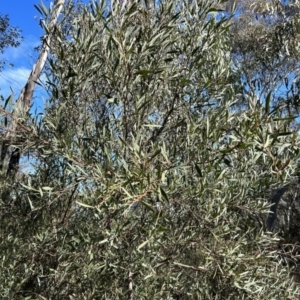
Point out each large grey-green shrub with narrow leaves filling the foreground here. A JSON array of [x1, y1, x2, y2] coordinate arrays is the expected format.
[[0, 0, 299, 299]]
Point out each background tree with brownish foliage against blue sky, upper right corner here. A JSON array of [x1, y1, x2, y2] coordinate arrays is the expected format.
[[223, 0, 300, 125]]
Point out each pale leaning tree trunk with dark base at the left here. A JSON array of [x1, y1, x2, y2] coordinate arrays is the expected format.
[[0, 0, 65, 178]]
